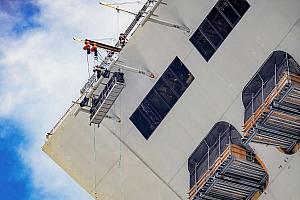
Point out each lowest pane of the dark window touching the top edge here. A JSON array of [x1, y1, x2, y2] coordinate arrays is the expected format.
[[190, 30, 215, 61]]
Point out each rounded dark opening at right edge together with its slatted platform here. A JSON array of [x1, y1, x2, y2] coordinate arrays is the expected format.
[[243, 51, 300, 153]]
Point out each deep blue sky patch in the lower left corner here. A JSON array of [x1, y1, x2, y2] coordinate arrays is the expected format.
[[0, 119, 32, 200]]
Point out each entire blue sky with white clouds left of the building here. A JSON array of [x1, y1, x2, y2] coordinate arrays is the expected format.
[[0, 0, 137, 200]]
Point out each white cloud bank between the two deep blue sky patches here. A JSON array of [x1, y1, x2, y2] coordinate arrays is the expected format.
[[0, 0, 144, 200]]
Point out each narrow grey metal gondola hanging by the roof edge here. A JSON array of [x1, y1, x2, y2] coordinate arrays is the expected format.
[[90, 72, 125, 124]]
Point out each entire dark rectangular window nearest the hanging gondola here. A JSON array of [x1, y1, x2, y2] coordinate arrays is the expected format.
[[130, 57, 194, 139]]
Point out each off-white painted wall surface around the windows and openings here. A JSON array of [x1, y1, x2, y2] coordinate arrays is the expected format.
[[43, 0, 300, 200]]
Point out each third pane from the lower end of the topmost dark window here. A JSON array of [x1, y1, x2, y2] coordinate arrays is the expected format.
[[207, 8, 232, 38]]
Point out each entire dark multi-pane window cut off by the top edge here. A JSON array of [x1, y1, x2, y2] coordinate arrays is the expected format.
[[190, 0, 250, 61]]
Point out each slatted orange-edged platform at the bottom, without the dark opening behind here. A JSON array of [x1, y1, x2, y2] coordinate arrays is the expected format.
[[190, 145, 268, 200]]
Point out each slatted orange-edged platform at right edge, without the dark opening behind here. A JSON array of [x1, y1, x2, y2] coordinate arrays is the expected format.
[[244, 74, 300, 152]]
